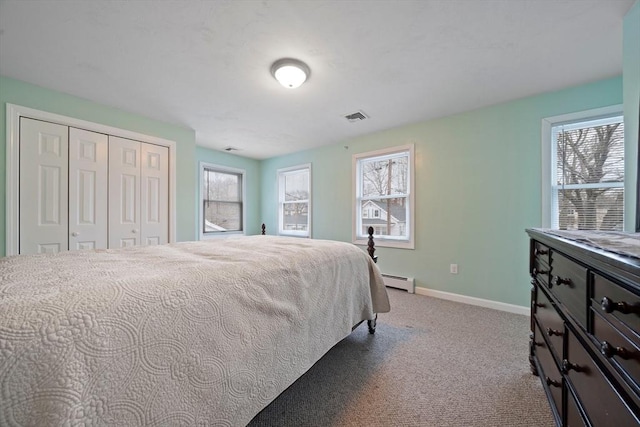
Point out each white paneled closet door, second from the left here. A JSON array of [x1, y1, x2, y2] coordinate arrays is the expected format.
[[69, 128, 109, 251]]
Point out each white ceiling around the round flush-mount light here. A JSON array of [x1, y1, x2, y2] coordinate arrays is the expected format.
[[0, 0, 634, 159]]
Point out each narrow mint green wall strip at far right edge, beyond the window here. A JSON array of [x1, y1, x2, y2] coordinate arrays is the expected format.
[[622, 0, 640, 231]]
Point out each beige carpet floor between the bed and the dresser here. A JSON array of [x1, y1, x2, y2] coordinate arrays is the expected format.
[[249, 289, 554, 427]]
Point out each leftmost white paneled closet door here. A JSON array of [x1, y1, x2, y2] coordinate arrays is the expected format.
[[19, 117, 69, 254]]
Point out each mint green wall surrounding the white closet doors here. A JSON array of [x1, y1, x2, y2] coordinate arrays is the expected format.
[[0, 76, 196, 256]]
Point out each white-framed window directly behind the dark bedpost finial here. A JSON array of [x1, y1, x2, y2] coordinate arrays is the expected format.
[[353, 145, 415, 249]]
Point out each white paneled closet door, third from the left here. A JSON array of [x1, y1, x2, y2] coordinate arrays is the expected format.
[[109, 136, 141, 248]]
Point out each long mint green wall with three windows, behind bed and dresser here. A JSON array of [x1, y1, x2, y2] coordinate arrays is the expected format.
[[262, 77, 622, 306]]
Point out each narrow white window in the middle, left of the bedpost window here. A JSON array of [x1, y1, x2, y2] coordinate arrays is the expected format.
[[278, 164, 311, 237]]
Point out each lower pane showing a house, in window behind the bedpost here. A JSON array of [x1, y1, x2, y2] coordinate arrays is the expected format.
[[360, 197, 407, 239]]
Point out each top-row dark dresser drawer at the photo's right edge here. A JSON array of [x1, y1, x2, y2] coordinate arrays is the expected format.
[[593, 274, 640, 344]]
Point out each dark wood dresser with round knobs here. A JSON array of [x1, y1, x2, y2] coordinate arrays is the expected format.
[[527, 229, 640, 426]]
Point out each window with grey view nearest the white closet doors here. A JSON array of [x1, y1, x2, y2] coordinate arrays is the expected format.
[[200, 163, 244, 238]]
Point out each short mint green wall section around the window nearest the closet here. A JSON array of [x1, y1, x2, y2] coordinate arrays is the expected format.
[[195, 147, 262, 234]]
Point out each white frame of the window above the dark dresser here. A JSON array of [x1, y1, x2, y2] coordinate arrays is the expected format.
[[542, 104, 627, 229]]
